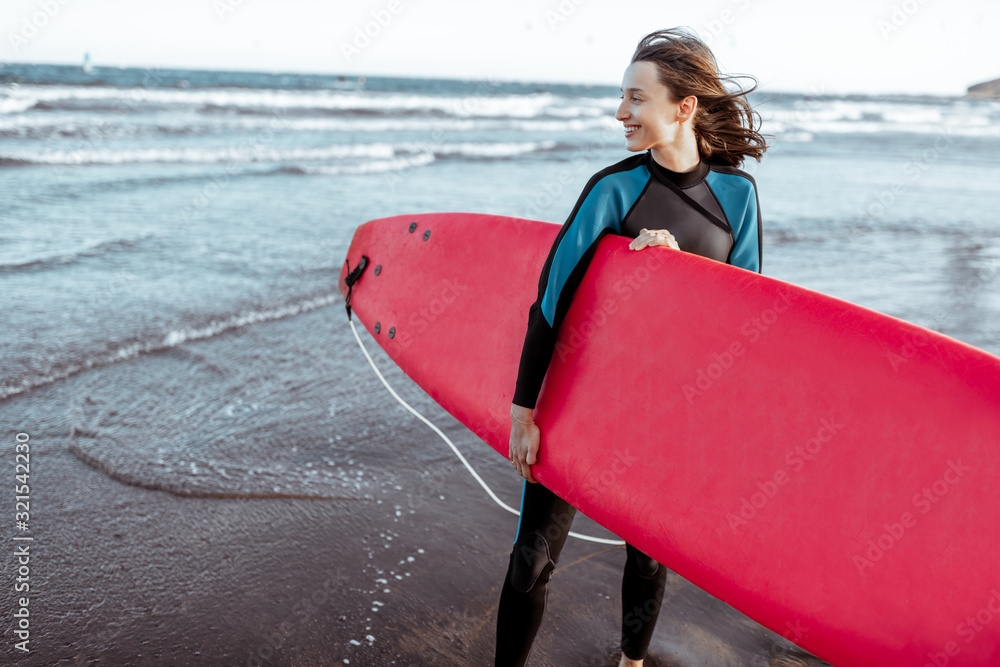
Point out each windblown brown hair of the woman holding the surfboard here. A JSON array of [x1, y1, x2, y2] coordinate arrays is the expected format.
[[632, 28, 767, 167]]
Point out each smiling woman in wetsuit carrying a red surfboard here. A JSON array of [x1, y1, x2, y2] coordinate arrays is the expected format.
[[495, 28, 767, 667]]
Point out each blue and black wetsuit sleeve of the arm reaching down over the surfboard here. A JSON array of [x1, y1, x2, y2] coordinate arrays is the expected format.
[[513, 174, 625, 408]]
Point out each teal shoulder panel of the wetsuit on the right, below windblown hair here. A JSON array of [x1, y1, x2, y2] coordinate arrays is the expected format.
[[705, 167, 762, 273]]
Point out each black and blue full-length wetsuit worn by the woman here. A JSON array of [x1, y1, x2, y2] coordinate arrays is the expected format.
[[495, 151, 763, 667]]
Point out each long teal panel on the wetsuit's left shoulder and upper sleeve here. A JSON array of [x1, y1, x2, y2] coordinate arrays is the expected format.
[[542, 165, 650, 327]]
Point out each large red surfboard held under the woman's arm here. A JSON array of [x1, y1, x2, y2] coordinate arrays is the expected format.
[[340, 213, 1000, 667]]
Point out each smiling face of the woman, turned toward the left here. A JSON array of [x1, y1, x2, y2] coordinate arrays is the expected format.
[[615, 60, 697, 152]]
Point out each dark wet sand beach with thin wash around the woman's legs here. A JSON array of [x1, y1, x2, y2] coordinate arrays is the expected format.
[[0, 304, 823, 666]]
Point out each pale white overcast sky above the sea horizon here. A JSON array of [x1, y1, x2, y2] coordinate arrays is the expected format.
[[0, 0, 1000, 95]]
